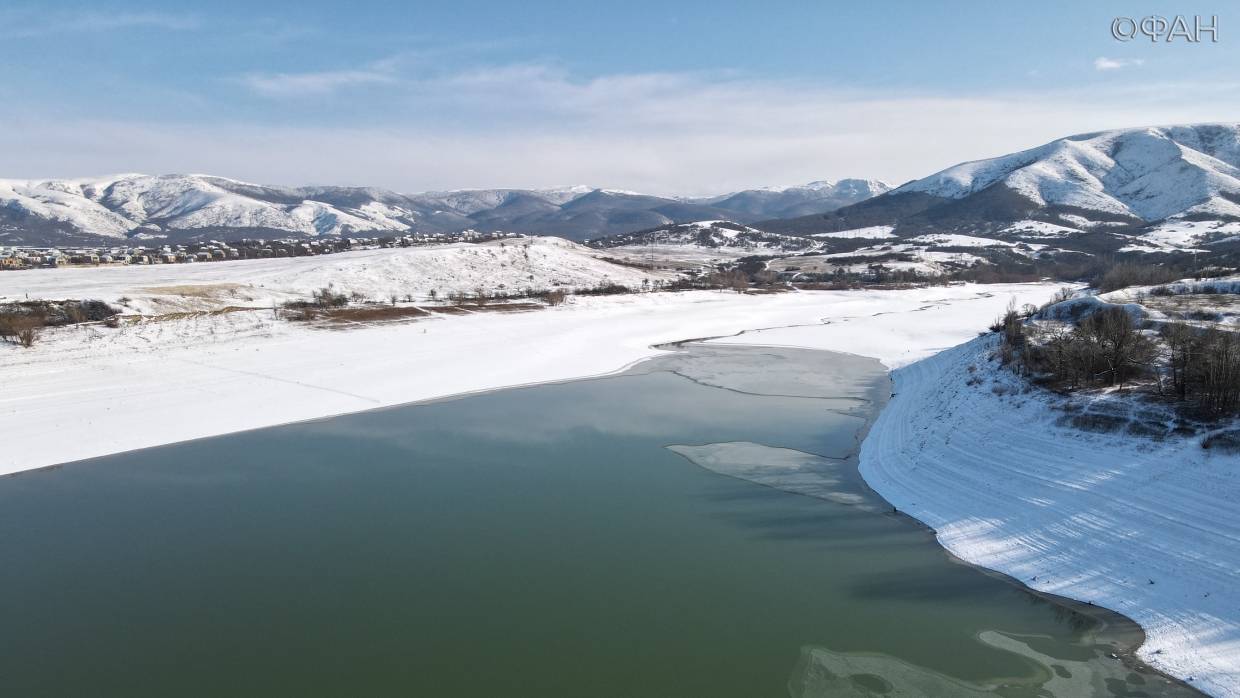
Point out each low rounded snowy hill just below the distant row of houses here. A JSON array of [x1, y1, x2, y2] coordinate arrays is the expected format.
[[0, 238, 671, 315]]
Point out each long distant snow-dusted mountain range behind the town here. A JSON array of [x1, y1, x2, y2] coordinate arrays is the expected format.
[[0, 175, 885, 244]]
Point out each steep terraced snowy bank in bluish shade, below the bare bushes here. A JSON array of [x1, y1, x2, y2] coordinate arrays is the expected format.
[[861, 337, 1240, 696]]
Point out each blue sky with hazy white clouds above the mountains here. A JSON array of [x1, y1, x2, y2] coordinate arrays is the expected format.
[[0, 0, 1240, 195]]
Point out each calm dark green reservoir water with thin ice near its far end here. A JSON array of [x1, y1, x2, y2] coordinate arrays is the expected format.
[[0, 348, 1192, 698]]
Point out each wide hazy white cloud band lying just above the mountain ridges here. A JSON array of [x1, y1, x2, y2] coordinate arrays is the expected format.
[[0, 64, 1240, 195]]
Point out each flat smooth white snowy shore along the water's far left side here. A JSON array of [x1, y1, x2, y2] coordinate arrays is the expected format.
[[0, 278, 1053, 474]]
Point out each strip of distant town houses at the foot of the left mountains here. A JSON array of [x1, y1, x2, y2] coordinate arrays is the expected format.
[[0, 231, 525, 270]]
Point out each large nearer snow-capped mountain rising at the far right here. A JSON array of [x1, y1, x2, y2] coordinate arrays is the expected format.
[[763, 123, 1240, 246]]
